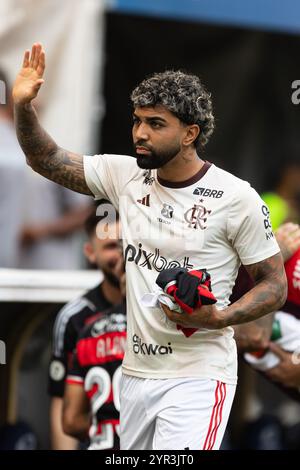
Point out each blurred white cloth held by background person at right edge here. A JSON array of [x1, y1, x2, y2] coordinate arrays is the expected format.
[[244, 311, 300, 371]]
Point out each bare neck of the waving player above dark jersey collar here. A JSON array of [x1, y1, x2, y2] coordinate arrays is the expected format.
[[157, 149, 204, 182]]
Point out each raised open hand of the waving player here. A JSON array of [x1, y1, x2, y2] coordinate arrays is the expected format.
[[12, 43, 45, 105]]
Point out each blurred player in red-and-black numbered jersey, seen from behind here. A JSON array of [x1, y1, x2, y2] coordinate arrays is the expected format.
[[63, 264, 126, 450]]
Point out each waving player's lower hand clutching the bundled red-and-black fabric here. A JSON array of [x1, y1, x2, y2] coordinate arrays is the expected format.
[[160, 303, 226, 330]]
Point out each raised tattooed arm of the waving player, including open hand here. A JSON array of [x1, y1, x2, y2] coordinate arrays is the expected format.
[[13, 44, 92, 195]]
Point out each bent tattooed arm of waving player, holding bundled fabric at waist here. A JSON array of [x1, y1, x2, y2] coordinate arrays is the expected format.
[[161, 253, 287, 329]]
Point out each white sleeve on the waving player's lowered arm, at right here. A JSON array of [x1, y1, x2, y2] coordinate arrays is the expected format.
[[227, 183, 280, 265]]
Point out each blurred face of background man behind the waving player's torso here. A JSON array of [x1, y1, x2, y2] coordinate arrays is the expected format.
[[84, 222, 123, 286]]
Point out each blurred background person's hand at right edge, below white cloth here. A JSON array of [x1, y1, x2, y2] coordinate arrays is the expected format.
[[265, 343, 300, 388]]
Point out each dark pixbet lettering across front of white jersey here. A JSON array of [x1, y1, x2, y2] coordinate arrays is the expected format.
[[125, 243, 194, 272]]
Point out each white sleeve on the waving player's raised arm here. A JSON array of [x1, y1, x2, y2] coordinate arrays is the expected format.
[[83, 155, 138, 208]]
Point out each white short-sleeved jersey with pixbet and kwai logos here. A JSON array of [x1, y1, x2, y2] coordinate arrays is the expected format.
[[84, 155, 279, 384]]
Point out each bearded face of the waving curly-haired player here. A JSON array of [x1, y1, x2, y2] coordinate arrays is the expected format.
[[132, 106, 186, 169]]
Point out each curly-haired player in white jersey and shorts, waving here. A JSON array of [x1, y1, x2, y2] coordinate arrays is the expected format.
[[13, 44, 286, 450]]
